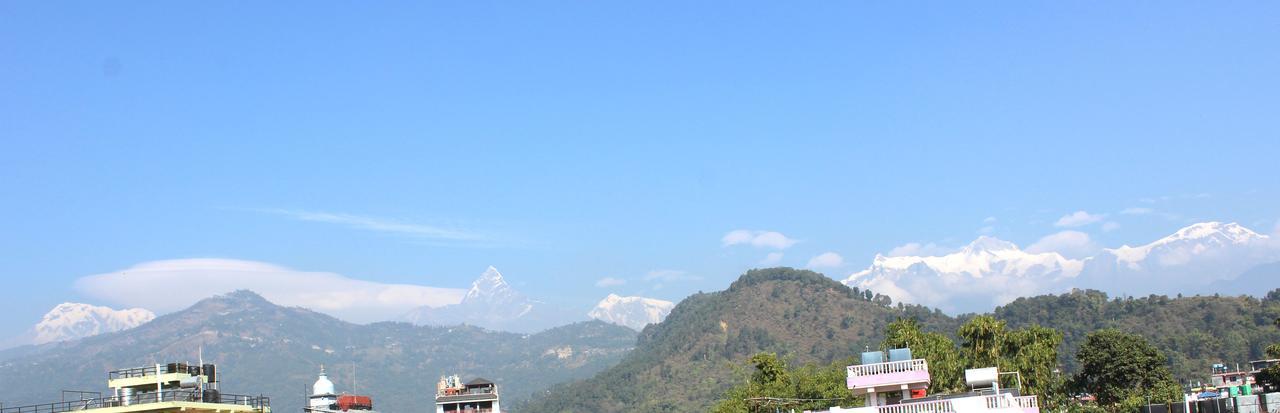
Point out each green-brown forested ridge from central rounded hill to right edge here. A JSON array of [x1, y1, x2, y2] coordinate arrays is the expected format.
[[520, 269, 1280, 413]]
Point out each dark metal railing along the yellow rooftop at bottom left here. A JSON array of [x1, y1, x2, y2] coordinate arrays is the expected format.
[[0, 390, 271, 413]]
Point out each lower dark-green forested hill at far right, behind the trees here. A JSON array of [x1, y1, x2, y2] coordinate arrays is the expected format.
[[995, 289, 1280, 382]]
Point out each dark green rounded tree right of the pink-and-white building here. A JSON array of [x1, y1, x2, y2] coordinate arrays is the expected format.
[[1074, 329, 1181, 412]]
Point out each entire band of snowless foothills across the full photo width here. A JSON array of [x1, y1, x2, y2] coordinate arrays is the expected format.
[[0, 267, 1280, 413]]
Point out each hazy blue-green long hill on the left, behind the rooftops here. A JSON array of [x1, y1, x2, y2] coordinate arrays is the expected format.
[[0, 290, 636, 412]]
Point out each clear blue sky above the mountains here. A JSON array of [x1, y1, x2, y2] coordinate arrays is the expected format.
[[0, 1, 1280, 335]]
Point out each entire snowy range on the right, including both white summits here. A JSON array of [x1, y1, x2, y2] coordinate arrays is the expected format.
[[844, 222, 1280, 312]]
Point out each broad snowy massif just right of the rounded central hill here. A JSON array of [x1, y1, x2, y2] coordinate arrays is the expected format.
[[844, 237, 1083, 315]]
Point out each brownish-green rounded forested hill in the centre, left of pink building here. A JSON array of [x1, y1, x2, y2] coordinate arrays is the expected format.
[[520, 269, 957, 412]]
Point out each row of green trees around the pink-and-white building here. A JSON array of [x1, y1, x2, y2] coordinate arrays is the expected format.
[[714, 316, 1182, 413]]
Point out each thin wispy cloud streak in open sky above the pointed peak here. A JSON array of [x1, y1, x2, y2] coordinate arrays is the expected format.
[[252, 208, 490, 242]]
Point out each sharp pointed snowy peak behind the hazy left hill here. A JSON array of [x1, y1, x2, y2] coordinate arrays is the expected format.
[[402, 266, 566, 332]]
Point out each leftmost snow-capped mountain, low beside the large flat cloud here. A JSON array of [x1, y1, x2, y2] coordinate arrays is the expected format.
[[31, 303, 156, 344]]
